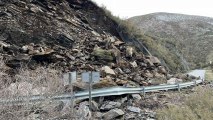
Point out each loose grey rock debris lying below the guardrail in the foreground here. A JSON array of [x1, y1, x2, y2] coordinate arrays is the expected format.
[[25, 94, 157, 120]]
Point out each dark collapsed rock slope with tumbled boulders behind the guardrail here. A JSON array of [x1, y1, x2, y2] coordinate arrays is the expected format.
[[0, 0, 166, 88]]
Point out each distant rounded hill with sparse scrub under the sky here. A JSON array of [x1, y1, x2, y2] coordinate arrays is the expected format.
[[128, 13, 213, 69]]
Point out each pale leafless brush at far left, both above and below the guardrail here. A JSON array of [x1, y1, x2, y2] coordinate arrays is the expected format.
[[0, 59, 81, 120]]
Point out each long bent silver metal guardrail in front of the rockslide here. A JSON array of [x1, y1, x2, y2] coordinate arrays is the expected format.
[[0, 79, 204, 105]]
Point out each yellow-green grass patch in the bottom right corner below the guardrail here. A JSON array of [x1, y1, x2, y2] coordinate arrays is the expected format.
[[157, 87, 213, 120]]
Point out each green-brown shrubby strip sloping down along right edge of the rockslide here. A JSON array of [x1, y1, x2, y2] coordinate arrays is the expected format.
[[102, 9, 180, 73]]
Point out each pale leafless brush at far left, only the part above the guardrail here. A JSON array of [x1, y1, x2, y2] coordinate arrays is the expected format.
[[0, 63, 64, 97]]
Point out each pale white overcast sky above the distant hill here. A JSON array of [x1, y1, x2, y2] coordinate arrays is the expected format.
[[93, 0, 213, 18]]
